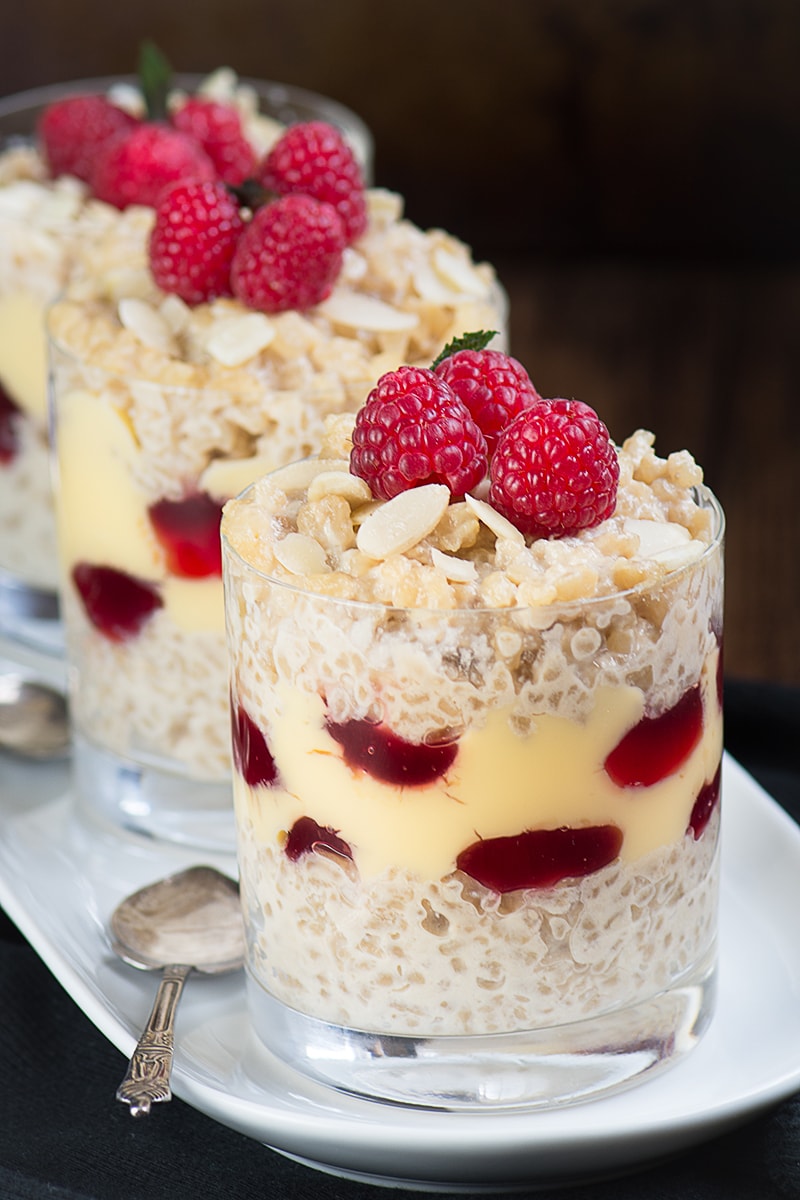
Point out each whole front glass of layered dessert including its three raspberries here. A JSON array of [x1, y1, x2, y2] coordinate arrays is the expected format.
[[222, 350, 723, 1109]]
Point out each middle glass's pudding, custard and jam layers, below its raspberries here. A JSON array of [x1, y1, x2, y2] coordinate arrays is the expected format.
[[49, 190, 505, 780]]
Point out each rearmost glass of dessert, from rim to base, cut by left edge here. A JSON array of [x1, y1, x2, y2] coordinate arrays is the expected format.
[[0, 68, 372, 658]]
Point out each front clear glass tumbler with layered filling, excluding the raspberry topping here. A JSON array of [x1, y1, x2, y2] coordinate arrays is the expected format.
[[222, 462, 723, 1109]]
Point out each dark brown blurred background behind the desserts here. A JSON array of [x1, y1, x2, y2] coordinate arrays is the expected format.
[[0, 0, 800, 685]]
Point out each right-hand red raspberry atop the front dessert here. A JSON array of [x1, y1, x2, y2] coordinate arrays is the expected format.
[[489, 400, 619, 538]]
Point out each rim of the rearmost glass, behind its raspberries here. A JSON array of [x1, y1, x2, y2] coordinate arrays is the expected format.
[[0, 71, 374, 172]]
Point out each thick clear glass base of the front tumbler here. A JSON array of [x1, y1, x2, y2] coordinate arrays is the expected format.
[[247, 950, 716, 1110]]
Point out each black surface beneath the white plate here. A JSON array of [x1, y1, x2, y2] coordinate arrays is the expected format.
[[0, 682, 800, 1200]]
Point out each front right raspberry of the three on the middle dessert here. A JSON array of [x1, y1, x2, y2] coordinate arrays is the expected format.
[[230, 196, 344, 312]]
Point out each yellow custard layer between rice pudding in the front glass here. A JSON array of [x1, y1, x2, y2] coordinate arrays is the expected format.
[[234, 653, 722, 878]]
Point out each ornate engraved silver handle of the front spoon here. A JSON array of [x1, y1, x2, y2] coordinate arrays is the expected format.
[[116, 966, 192, 1117]]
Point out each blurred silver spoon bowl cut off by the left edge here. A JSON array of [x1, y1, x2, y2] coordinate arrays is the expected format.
[[0, 673, 70, 760]]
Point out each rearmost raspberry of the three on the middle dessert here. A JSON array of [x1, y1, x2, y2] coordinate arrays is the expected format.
[[258, 121, 367, 245]]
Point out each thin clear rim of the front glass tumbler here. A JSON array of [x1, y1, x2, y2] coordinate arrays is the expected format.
[[219, 460, 726, 628]]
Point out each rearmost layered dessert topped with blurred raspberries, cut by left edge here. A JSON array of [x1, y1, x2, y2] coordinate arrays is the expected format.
[[0, 60, 369, 614]]
